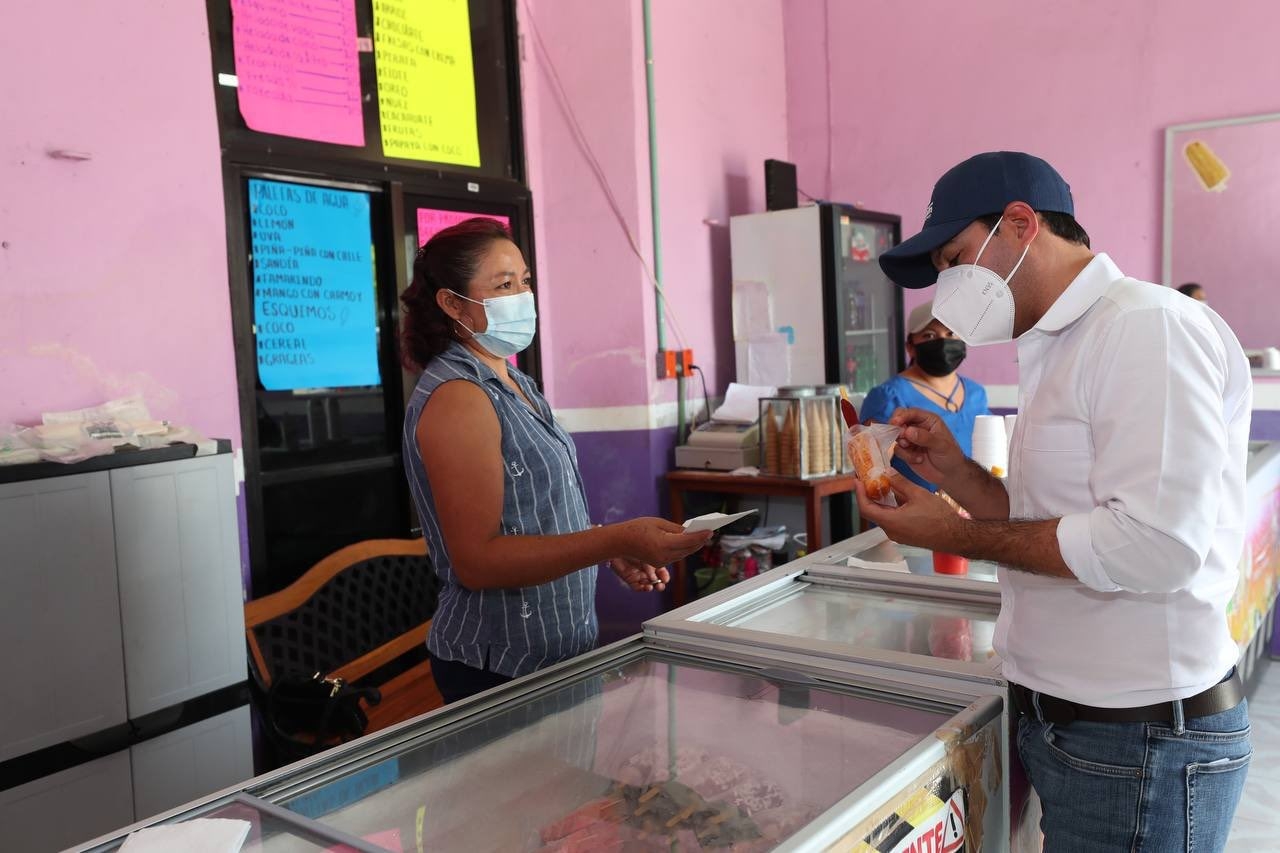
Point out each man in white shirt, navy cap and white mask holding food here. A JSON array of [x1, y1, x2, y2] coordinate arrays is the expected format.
[[859, 152, 1252, 852]]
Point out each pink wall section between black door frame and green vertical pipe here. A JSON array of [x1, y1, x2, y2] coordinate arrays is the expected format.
[[518, 0, 655, 409]]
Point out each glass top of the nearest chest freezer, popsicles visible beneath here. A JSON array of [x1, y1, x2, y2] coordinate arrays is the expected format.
[[192, 638, 1002, 850]]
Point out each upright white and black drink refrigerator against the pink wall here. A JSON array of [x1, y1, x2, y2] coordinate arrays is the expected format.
[[730, 202, 905, 393]]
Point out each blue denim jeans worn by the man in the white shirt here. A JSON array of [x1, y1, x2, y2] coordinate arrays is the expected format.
[[1018, 701, 1253, 853]]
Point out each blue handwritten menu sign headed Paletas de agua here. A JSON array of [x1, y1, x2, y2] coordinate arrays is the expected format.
[[248, 178, 381, 391]]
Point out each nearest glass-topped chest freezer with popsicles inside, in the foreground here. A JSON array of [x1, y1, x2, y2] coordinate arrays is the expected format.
[[79, 631, 1006, 853]]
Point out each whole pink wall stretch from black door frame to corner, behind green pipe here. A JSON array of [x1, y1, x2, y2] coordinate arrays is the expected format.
[[518, 0, 787, 409]]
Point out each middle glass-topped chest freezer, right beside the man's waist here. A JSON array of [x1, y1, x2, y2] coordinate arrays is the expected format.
[[645, 530, 1039, 849]]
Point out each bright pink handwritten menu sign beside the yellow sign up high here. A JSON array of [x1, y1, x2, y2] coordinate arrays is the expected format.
[[232, 0, 365, 145]]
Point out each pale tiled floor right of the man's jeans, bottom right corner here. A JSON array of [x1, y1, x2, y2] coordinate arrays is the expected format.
[[1226, 661, 1280, 853]]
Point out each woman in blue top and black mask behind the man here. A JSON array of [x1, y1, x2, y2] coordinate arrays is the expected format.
[[860, 302, 991, 492]]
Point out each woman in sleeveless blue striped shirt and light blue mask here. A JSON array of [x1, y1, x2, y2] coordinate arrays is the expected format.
[[402, 218, 709, 702]]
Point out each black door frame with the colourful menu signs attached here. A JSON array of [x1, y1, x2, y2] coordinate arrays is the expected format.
[[207, 0, 543, 576]]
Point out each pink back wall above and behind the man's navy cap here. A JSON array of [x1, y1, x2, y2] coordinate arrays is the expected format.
[[783, 0, 1280, 383]]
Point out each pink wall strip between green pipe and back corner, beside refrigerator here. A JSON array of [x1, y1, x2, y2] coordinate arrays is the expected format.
[[653, 0, 787, 397]]
